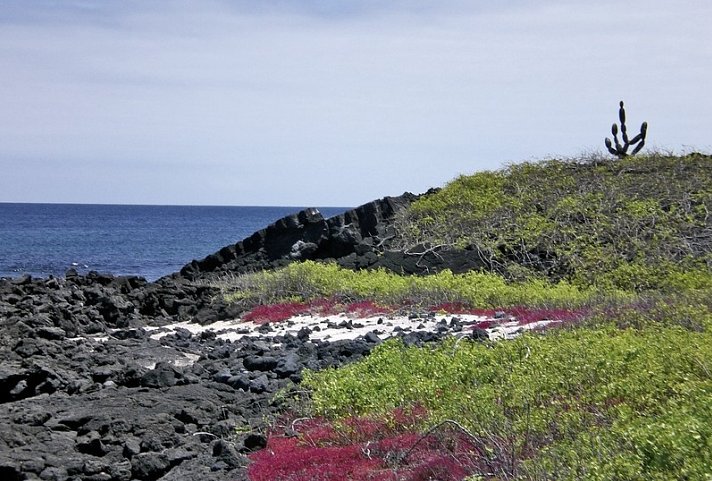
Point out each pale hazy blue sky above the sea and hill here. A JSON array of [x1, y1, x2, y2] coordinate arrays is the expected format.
[[0, 0, 712, 207]]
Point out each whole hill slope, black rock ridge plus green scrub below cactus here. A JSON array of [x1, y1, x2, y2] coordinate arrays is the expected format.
[[188, 154, 712, 291]]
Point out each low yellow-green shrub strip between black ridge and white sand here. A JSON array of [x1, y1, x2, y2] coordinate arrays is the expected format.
[[221, 261, 600, 308]]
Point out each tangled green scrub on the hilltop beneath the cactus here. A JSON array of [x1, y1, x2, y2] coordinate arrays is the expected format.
[[398, 154, 712, 290]]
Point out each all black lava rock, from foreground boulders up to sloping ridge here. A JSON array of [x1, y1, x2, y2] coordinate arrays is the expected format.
[[0, 194, 536, 481]]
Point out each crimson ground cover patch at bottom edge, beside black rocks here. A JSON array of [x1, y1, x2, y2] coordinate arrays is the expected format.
[[248, 409, 482, 481]]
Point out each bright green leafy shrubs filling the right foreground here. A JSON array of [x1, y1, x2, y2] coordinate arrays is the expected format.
[[305, 294, 712, 481]]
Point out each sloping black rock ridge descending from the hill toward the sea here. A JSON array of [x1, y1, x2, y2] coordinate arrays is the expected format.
[[180, 190, 490, 280]]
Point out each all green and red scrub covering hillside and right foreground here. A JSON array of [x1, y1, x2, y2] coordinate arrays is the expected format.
[[236, 154, 712, 481]]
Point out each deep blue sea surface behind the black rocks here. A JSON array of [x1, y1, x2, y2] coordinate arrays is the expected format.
[[0, 203, 347, 281]]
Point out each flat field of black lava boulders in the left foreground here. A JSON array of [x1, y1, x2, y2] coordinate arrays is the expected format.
[[0, 275, 486, 481]]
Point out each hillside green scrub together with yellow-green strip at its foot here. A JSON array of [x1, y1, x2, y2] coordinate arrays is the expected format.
[[221, 154, 712, 314]]
